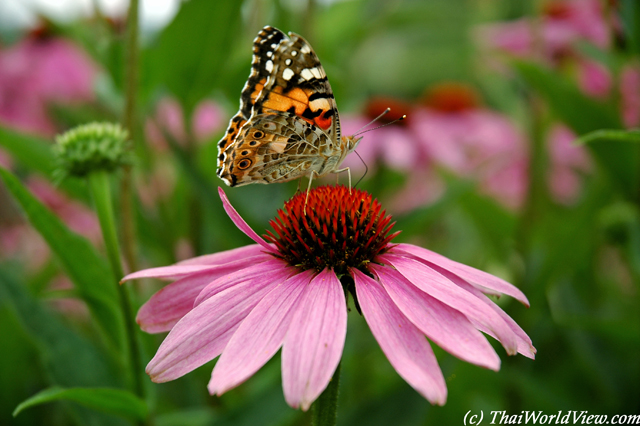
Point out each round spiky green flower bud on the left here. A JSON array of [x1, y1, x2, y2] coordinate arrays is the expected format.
[[54, 123, 131, 178]]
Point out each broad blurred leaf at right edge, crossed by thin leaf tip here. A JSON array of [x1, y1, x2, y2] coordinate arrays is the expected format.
[[514, 62, 640, 199]]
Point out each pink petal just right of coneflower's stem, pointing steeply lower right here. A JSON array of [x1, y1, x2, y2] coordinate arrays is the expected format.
[[351, 269, 447, 405]]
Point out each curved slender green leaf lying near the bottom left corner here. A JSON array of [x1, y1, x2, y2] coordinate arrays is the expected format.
[[13, 387, 148, 420]]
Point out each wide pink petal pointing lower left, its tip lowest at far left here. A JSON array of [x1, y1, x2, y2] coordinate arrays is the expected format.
[[147, 262, 278, 383]]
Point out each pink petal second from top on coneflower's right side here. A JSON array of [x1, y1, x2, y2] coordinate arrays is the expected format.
[[380, 253, 518, 355]]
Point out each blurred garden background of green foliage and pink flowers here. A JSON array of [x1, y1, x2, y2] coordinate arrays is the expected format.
[[0, 0, 640, 426]]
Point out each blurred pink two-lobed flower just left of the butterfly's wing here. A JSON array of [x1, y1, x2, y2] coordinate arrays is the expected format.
[[145, 98, 224, 150]]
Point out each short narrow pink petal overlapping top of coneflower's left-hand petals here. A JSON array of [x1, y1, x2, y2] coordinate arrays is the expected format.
[[193, 256, 297, 306]]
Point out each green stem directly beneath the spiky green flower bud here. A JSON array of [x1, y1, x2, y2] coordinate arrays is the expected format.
[[87, 170, 144, 397]]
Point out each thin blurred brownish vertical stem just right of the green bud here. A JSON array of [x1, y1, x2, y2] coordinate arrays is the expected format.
[[120, 0, 139, 271]]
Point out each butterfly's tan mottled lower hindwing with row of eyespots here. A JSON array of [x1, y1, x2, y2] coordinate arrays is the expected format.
[[219, 112, 340, 186]]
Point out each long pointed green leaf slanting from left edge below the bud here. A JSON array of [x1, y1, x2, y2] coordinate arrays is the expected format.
[[0, 168, 124, 348]]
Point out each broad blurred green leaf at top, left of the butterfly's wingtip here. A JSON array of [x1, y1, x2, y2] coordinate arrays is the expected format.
[[142, 0, 242, 112]]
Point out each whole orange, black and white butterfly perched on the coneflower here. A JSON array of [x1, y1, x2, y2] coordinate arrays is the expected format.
[[217, 26, 362, 187]]
